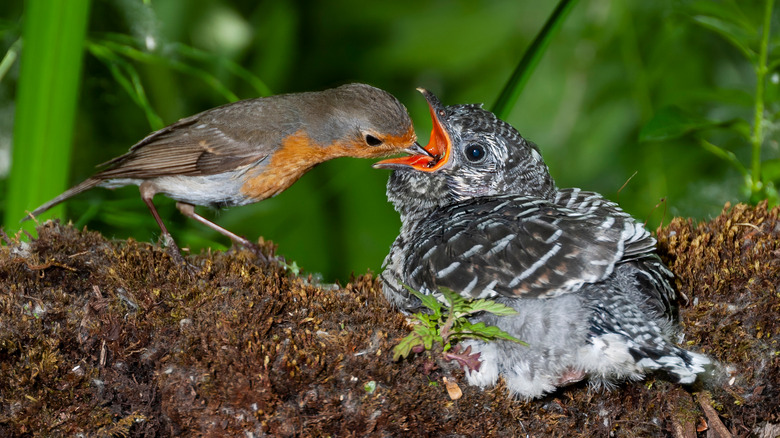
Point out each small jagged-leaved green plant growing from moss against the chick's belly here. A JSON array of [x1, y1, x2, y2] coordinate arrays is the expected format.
[[393, 285, 528, 367]]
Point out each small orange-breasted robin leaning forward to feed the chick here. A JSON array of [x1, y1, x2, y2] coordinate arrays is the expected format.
[[25, 84, 426, 257]]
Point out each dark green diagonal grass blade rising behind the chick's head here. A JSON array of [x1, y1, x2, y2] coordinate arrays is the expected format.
[[492, 0, 576, 119]]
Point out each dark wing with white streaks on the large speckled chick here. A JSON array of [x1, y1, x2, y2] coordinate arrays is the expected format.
[[404, 196, 652, 298]]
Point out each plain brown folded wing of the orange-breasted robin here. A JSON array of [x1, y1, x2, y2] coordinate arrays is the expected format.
[[95, 98, 297, 179]]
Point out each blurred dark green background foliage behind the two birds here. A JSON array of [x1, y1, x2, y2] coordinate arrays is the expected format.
[[0, 0, 780, 281]]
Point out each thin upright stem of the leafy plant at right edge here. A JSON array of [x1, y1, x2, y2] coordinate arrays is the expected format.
[[751, 0, 774, 197]]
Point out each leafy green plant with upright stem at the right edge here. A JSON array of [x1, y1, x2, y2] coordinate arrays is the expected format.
[[640, 0, 780, 205]]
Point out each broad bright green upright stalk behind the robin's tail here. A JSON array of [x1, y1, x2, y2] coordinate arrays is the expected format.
[[4, 0, 90, 231]]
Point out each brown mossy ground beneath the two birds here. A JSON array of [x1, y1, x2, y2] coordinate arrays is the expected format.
[[0, 205, 780, 437]]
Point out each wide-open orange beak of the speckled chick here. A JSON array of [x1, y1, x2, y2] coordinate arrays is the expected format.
[[374, 88, 452, 172]]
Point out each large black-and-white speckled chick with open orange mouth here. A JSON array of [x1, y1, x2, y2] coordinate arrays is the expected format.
[[375, 90, 713, 398]]
